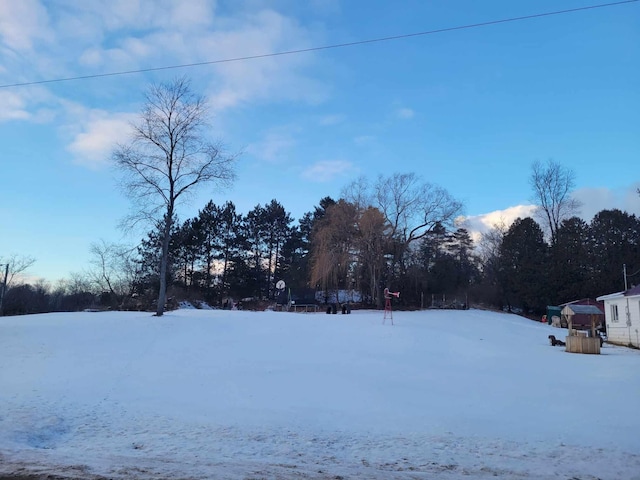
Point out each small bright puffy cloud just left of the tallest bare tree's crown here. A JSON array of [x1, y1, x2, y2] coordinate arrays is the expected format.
[[68, 111, 136, 168]]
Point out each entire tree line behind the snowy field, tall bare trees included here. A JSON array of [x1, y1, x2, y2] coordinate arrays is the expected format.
[[0, 78, 640, 316]]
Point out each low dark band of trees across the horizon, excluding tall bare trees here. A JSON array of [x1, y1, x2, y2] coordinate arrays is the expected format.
[[4, 197, 640, 315]]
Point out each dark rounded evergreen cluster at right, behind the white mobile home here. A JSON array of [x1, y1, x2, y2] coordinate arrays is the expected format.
[[481, 210, 640, 313]]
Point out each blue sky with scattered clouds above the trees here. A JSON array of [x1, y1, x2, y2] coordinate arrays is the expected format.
[[0, 0, 640, 282]]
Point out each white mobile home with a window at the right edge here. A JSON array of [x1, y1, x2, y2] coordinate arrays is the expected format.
[[597, 285, 640, 348]]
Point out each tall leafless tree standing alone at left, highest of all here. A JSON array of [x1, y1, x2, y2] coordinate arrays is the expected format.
[[113, 78, 236, 316]]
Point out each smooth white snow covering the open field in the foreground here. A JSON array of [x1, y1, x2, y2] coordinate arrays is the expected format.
[[0, 308, 640, 480]]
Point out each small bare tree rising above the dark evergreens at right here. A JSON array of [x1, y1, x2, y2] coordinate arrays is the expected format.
[[529, 160, 582, 245]]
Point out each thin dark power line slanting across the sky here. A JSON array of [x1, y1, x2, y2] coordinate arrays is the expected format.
[[0, 0, 640, 88]]
